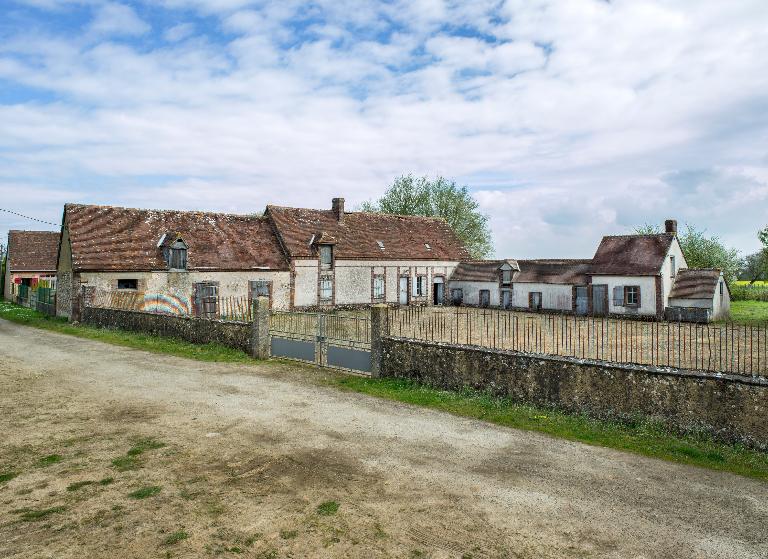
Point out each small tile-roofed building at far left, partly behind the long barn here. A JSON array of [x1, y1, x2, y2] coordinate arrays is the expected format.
[[3, 230, 59, 304]]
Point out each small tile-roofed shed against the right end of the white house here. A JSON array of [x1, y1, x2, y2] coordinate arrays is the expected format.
[[666, 268, 731, 322]]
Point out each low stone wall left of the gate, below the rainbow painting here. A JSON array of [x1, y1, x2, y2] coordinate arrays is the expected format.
[[82, 306, 252, 352]]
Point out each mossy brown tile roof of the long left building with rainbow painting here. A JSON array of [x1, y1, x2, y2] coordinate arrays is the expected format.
[[64, 204, 288, 271]]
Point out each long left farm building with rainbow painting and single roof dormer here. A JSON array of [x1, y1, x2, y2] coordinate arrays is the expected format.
[[57, 204, 290, 318]]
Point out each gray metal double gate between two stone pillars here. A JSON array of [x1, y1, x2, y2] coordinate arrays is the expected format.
[[269, 311, 371, 373]]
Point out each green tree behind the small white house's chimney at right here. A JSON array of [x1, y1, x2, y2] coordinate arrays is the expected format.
[[635, 224, 744, 283]]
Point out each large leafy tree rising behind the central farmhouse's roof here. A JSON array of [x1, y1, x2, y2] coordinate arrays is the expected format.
[[360, 175, 493, 258]]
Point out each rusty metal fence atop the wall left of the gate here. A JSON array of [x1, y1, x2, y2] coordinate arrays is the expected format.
[[87, 290, 253, 322]]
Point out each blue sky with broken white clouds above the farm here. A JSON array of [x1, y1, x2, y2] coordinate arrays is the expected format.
[[0, 0, 768, 258]]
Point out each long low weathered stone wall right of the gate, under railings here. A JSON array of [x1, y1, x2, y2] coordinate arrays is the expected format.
[[379, 337, 768, 449]]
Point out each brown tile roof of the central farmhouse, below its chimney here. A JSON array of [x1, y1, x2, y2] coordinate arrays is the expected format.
[[266, 206, 468, 261]]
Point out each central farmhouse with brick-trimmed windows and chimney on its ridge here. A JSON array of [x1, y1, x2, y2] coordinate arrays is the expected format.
[[264, 198, 468, 308]]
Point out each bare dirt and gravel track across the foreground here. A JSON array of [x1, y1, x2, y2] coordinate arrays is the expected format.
[[0, 321, 768, 559]]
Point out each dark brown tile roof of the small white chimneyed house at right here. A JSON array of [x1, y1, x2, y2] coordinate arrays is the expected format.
[[590, 233, 675, 276]]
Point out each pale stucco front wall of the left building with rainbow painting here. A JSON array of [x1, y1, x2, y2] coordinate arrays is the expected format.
[[80, 271, 290, 309]]
